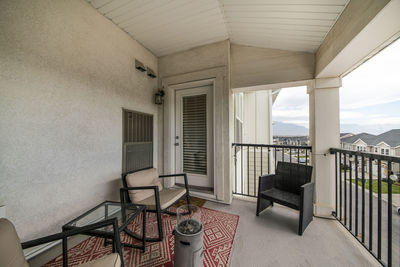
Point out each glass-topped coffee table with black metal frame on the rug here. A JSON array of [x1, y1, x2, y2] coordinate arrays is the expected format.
[[62, 201, 146, 256]]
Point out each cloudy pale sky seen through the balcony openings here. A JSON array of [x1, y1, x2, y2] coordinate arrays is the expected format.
[[272, 40, 400, 134]]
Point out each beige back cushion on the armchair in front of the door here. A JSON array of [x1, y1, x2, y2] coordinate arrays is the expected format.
[[126, 168, 163, 203]]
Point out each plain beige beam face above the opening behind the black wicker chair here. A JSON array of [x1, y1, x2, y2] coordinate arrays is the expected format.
[[231, 44, 314, 88]]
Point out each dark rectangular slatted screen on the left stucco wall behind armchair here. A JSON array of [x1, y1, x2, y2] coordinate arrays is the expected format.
[[123, 110, 153, 172]]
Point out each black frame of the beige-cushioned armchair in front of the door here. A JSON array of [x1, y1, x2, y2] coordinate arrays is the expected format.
[[120, 168, 190, 242]]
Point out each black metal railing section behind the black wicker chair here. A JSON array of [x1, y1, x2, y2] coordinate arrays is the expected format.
[[232, 143, 311, 197]]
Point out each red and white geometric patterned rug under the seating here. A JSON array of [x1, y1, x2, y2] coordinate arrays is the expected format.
[[44, 208, 239, 267]]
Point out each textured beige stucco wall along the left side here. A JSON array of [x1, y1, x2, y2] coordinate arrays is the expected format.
[[0, 0, 158, 240]]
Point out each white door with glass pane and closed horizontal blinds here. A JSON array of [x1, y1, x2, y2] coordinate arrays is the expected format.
[[175, 85, 214, 191]]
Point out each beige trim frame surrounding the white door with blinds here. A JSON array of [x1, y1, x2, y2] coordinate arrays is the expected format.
[[159, 66, 230, 204]]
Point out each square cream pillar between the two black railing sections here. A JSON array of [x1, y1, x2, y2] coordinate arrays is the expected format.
[[307, 77, 342, 216]]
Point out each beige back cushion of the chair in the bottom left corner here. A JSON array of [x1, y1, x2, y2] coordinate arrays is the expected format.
[[0, 218, 29, 267]]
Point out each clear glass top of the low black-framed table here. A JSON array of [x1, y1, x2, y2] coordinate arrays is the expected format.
[[64, 201, 143, 232]]
